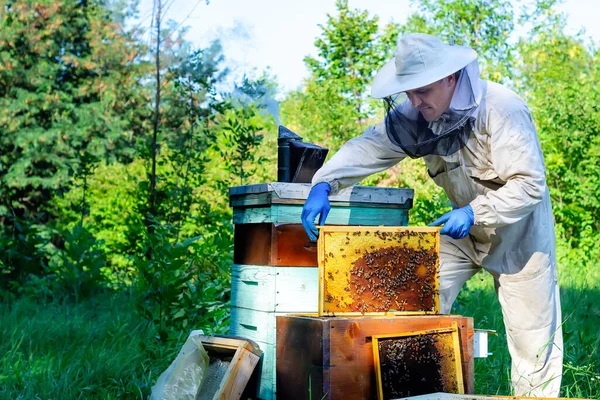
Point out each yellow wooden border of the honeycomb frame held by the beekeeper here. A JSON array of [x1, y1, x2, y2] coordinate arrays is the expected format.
[[317, 226, 441, 316]]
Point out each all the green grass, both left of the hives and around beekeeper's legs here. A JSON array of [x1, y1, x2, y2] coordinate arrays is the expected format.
[[0, 267, 600, 400]]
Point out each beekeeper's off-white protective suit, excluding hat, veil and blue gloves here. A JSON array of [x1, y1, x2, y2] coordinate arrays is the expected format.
[[312, 82, 563, 397]]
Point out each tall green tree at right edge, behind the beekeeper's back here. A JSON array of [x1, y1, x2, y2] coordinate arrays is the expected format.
[[516, 1, 600, 264]]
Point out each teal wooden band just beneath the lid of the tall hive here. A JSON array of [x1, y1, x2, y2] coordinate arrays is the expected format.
[[233, 204, 408, 226]]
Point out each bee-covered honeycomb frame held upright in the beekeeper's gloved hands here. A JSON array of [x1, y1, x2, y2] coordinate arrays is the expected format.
[[319, 226, 440, 315]]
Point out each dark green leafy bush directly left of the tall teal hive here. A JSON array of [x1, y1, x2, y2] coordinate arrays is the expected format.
[[135, 220, 231, 341]]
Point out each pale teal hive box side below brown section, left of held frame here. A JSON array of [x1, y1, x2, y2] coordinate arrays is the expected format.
[[275, 267, 319, 313]]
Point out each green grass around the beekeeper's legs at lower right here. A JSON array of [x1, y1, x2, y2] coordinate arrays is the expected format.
[[452, 260, 600, 399]]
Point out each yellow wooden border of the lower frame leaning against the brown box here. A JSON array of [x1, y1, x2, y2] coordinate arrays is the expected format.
[[372, 322, 465, 400]]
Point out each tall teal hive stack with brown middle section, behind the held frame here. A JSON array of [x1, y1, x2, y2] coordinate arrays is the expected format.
[[229, 182, 414, 400]]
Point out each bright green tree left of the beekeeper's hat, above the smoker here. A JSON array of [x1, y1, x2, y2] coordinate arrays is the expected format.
[[282, 0, 398, 150]]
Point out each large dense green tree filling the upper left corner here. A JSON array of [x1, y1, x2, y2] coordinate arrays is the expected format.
[[0, 0, 148, 222]]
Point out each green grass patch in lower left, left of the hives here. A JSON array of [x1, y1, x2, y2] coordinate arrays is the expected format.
[[0, 295, 185, 400]]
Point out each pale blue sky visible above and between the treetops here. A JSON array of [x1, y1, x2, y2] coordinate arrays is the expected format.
[[131, 0, 600, 91]]
